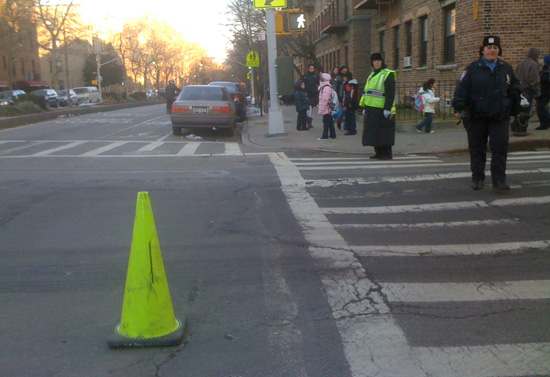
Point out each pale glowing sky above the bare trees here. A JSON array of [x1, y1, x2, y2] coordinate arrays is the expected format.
[[74, 0, 235, 61]]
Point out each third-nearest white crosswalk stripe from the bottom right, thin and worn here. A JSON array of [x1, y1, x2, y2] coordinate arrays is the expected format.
[[350, 240, 550, 257]]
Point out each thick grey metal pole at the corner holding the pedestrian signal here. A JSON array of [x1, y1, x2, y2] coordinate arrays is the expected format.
[[266, 9, 285, 136]]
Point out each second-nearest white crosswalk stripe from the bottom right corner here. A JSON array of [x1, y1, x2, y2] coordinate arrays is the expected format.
[[380, 280, 550, 302]]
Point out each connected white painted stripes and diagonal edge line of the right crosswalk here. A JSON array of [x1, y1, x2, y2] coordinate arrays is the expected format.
[[270, 152, 550, 377]]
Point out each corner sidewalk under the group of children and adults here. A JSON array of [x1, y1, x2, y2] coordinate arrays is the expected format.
[[242, 106, 550, 155]]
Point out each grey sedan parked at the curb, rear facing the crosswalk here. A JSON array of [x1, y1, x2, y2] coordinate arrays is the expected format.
[[170, 85, 237, 135]]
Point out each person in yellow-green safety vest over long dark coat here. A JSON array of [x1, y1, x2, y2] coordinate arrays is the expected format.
[[359, 52, 396, 160]]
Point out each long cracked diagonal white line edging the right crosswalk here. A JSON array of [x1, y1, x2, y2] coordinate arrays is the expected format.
[[270, 153, 426, 377]]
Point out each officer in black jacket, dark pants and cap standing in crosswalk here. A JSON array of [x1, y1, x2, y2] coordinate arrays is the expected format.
[[452, 36, 521, 190]]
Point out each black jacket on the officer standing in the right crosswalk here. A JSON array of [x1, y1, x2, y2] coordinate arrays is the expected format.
[[452, 58, 521, 120]]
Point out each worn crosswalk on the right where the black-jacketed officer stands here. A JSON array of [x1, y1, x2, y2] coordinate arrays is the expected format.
[[270, 152, 550, 377]]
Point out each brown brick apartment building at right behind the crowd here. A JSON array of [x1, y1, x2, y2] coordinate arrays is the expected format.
[[296, 0, 550, 108]]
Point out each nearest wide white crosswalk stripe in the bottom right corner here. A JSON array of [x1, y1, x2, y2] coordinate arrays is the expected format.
[[416, 343, 550, 377]]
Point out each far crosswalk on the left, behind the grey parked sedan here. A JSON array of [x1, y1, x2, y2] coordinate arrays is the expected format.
[[0, 140, 244, 159]]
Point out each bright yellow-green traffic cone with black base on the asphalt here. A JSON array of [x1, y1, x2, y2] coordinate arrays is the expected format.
[[107, 192, 184, 347]]
